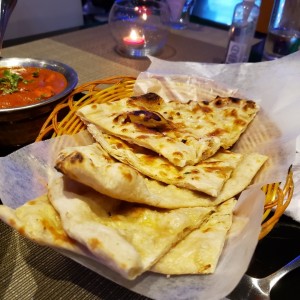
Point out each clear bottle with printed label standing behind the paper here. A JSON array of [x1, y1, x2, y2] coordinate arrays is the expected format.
[[225, 0, 259, 63]]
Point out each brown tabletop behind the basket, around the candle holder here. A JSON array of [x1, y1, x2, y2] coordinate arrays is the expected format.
[[1, 25, 227, 82]]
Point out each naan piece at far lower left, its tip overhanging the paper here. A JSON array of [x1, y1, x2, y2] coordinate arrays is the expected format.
[[0, 194, 87, 254]]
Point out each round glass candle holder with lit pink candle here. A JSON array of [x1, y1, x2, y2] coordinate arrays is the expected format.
[[108, 0, 170, 57]]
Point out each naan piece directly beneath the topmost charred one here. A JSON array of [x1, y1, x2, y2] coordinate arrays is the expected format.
[[87, 124, 242, 197]]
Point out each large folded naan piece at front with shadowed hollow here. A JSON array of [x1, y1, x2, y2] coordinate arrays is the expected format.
[[49, 177, 213, 279]]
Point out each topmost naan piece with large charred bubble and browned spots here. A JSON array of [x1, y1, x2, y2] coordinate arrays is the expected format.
[[77, 93, 259, 167]]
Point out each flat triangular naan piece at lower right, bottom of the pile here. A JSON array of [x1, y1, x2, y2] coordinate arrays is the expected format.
[[151, 198, 236, 275]]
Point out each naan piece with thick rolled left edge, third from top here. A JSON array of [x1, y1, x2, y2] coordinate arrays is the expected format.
[[56, 143, 267, 208]]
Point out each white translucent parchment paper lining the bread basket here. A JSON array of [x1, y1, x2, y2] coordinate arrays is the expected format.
[[0, 53, 300, 300]]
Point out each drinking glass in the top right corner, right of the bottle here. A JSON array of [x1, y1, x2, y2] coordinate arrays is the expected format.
[[264, 0, 300, 60]]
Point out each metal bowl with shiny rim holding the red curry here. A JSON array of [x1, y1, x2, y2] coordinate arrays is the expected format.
[[0, 58, 78, 148]]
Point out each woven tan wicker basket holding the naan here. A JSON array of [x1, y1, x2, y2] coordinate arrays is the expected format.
[[36, 76, 294, 239]]
